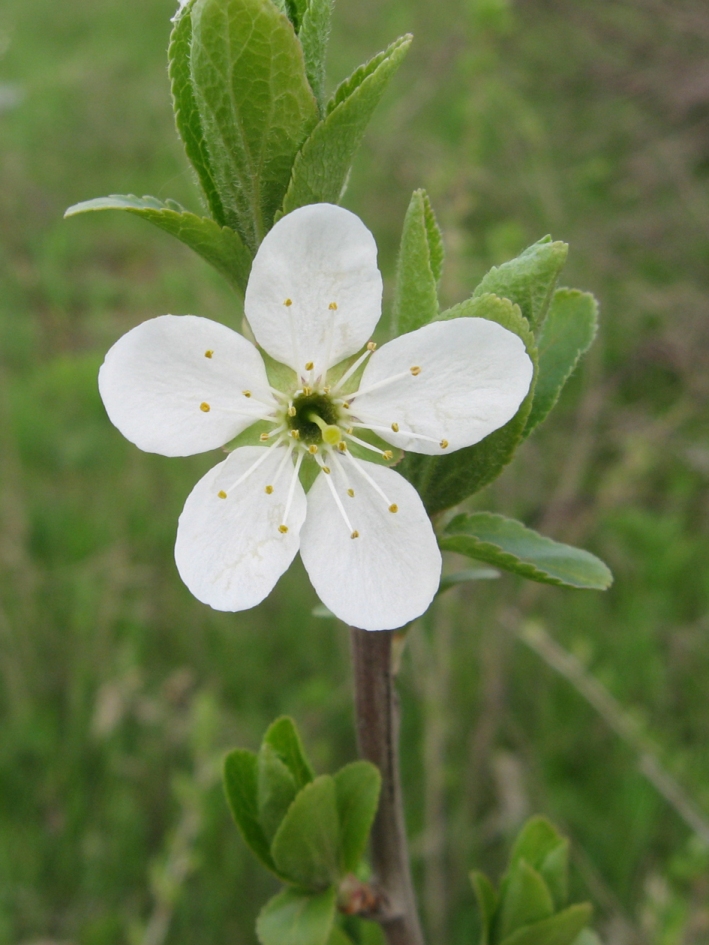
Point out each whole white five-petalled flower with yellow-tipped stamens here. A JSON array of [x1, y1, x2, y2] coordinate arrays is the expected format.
[[99, 204, 533, 630]]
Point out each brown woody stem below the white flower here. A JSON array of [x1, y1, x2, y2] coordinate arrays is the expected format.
[[351, 627, 423, 945]]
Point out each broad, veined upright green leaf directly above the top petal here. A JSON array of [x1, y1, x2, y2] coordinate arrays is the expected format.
[[191, 0, 319, 251]]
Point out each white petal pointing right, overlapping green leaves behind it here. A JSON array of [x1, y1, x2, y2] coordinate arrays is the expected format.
[[351, 318, 534, 455]]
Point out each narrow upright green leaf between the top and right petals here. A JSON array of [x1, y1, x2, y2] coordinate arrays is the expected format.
[[392, 190, 443, 335]]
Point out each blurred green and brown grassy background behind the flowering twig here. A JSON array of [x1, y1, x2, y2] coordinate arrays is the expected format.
[[0, 0, 709, 945]]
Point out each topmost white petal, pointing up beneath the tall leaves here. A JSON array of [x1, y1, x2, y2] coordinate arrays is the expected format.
[[244, 203, 382, 377]]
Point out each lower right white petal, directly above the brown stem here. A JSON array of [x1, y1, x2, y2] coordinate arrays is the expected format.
[[300, 463, 441, 630]]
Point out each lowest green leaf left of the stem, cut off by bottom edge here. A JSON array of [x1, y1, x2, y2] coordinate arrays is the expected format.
[[256, 889, 336, 945]]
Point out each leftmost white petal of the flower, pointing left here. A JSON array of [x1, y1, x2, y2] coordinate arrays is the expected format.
[[99, 315, 276, 456]]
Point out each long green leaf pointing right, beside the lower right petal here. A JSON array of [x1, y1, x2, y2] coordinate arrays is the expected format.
[[439, 512, 613, 591]]
